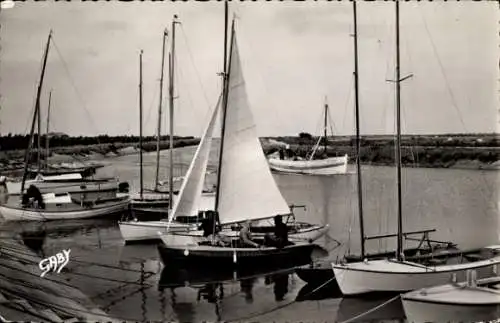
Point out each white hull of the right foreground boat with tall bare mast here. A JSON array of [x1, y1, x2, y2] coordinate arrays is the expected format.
[[332, 257, 500, 296]]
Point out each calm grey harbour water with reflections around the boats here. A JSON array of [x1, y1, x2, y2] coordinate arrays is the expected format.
[[0, 148, 500, 322]]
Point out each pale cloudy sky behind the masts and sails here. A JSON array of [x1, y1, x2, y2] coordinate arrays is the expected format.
[[0, 0, 500, 136]]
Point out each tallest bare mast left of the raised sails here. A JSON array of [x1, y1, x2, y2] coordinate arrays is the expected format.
[[168, 15, 178, 210]]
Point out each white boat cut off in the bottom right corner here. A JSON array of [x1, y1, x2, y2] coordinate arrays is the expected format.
[[401, 271, 500, 323]]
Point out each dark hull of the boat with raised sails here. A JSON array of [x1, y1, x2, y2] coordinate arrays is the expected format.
[[158, 243, 315, 269]]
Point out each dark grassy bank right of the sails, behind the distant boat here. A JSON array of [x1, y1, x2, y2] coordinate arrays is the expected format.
[[265, 134, 500, 169]]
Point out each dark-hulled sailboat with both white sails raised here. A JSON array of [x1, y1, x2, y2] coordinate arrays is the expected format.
[[158, 13, 324, 268]]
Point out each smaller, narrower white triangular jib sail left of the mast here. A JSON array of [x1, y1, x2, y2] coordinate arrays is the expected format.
[[170, 93, 221, 220]]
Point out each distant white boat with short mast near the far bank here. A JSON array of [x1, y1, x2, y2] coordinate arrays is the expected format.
[[268, 102, 349, 175]]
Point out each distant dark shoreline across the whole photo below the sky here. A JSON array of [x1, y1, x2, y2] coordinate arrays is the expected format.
[[0, 134, 500, 175]]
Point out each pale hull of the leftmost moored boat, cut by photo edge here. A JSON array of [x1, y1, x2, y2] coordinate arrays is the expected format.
[[0, 198, 128, 221]]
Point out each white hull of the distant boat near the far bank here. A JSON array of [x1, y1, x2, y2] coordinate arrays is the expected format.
[[268, 155, 348, 175]]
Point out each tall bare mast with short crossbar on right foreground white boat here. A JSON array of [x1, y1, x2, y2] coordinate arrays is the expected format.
[[396, 0, 404, 260]]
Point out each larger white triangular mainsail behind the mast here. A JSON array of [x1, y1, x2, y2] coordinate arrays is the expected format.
[[217, 35, 290, 224]]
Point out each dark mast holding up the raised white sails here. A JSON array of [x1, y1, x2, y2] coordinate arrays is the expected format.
[[215, 0, 230, 212]]
